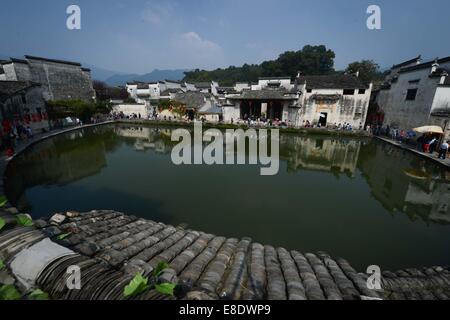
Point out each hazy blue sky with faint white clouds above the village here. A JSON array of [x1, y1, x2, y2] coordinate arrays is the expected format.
[[0, 0, 450, 74]]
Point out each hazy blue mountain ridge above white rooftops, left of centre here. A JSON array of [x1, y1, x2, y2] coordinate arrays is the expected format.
[[103, 69, 189, 86]]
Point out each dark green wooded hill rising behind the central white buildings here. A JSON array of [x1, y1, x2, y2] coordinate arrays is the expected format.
[[183, 45, 336, 86]]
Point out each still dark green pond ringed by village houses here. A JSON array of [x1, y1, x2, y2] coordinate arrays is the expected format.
[[5, 125, 450, 271]]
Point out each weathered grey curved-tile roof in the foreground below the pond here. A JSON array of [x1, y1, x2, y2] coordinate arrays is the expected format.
[[0, 211, 450, 300]]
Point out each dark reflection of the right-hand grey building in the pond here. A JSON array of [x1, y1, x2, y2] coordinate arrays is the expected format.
[[358, 141, 450, 224]]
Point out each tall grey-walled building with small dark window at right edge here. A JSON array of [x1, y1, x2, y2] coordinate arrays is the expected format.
[[376, 57, 450, 138]]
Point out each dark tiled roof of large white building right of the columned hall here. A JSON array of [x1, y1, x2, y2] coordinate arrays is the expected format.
[[298, 74, 369, 89]]
